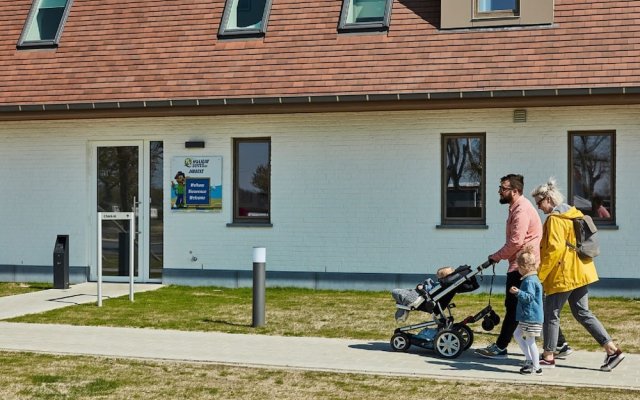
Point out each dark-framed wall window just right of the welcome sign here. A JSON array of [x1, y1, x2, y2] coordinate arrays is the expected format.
[[233, 138, 271, 224]]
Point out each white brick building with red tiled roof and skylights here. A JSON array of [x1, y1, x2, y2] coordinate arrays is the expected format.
[[0, 0, 640, 295]]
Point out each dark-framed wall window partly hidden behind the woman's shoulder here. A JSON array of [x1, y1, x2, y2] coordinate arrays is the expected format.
[[569, 131, 615, 224]]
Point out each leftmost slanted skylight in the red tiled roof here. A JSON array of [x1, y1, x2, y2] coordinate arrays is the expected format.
[[18, 0, 72, 48]]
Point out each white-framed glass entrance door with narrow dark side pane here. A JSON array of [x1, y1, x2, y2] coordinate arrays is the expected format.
[[91, 141, 164, 282]]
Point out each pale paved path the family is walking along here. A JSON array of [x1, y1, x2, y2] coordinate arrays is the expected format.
[[0, 284, 640, 395]]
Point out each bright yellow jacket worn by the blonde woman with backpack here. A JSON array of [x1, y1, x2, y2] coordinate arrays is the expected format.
[[538, 207, 598, 294]]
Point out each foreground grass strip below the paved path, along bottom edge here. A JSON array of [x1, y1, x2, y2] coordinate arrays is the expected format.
[[0, 352, 638, 400]]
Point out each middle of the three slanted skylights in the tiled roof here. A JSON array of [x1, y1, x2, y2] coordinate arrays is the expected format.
[[218, 0, 271, 37]]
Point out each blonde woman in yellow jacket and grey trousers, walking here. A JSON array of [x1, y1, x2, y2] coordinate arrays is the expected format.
[[531, 178, 624, 371]]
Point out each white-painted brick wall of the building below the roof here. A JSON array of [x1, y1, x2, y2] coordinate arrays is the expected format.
[[0, 106, 640, 278]]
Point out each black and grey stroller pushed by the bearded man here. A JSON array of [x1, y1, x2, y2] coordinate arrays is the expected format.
[[391, 261, 500, 358]]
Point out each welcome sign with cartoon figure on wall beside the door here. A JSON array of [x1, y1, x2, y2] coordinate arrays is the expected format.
[[170, 156, 222, 211]]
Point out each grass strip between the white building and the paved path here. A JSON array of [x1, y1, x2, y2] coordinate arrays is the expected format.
[[10, 286, 640, 352]]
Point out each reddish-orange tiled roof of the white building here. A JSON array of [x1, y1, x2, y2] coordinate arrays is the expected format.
[[0, 0, 640, 109]]
